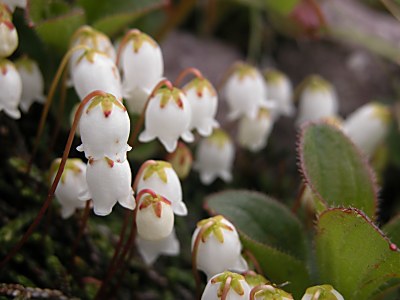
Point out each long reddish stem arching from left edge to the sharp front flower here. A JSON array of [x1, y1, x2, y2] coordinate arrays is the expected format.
[[0, 91, 105, 269]]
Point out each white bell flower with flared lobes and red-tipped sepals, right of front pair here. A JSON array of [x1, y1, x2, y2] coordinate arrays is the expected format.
[[139, 87, 194, 152]]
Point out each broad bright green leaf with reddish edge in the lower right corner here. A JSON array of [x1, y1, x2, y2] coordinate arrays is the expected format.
[[316, 208, 400, 300]]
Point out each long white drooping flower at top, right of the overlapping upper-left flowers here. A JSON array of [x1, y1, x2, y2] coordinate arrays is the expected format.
[[120, 29, 164, 114]]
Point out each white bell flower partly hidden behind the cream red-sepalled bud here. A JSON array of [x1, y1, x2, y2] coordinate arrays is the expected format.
[[134, 160, 187, 216]]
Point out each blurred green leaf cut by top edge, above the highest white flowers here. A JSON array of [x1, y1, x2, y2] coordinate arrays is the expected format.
[[78, 0, 165, 36]]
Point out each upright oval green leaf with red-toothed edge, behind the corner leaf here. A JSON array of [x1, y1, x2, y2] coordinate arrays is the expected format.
[[298, 123, 377, 218]]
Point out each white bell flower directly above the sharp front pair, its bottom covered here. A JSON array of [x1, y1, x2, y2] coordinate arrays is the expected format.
[[71, 50, 122, 101]]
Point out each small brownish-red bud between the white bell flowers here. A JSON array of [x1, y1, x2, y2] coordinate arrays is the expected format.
[[167, 142, 193, 180]]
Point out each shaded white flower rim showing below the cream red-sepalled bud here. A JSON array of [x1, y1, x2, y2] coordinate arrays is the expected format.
[[136, 230, 180, 266]]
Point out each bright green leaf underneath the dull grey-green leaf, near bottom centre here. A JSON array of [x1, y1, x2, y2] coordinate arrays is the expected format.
[[240, 232, 311, 299]]
